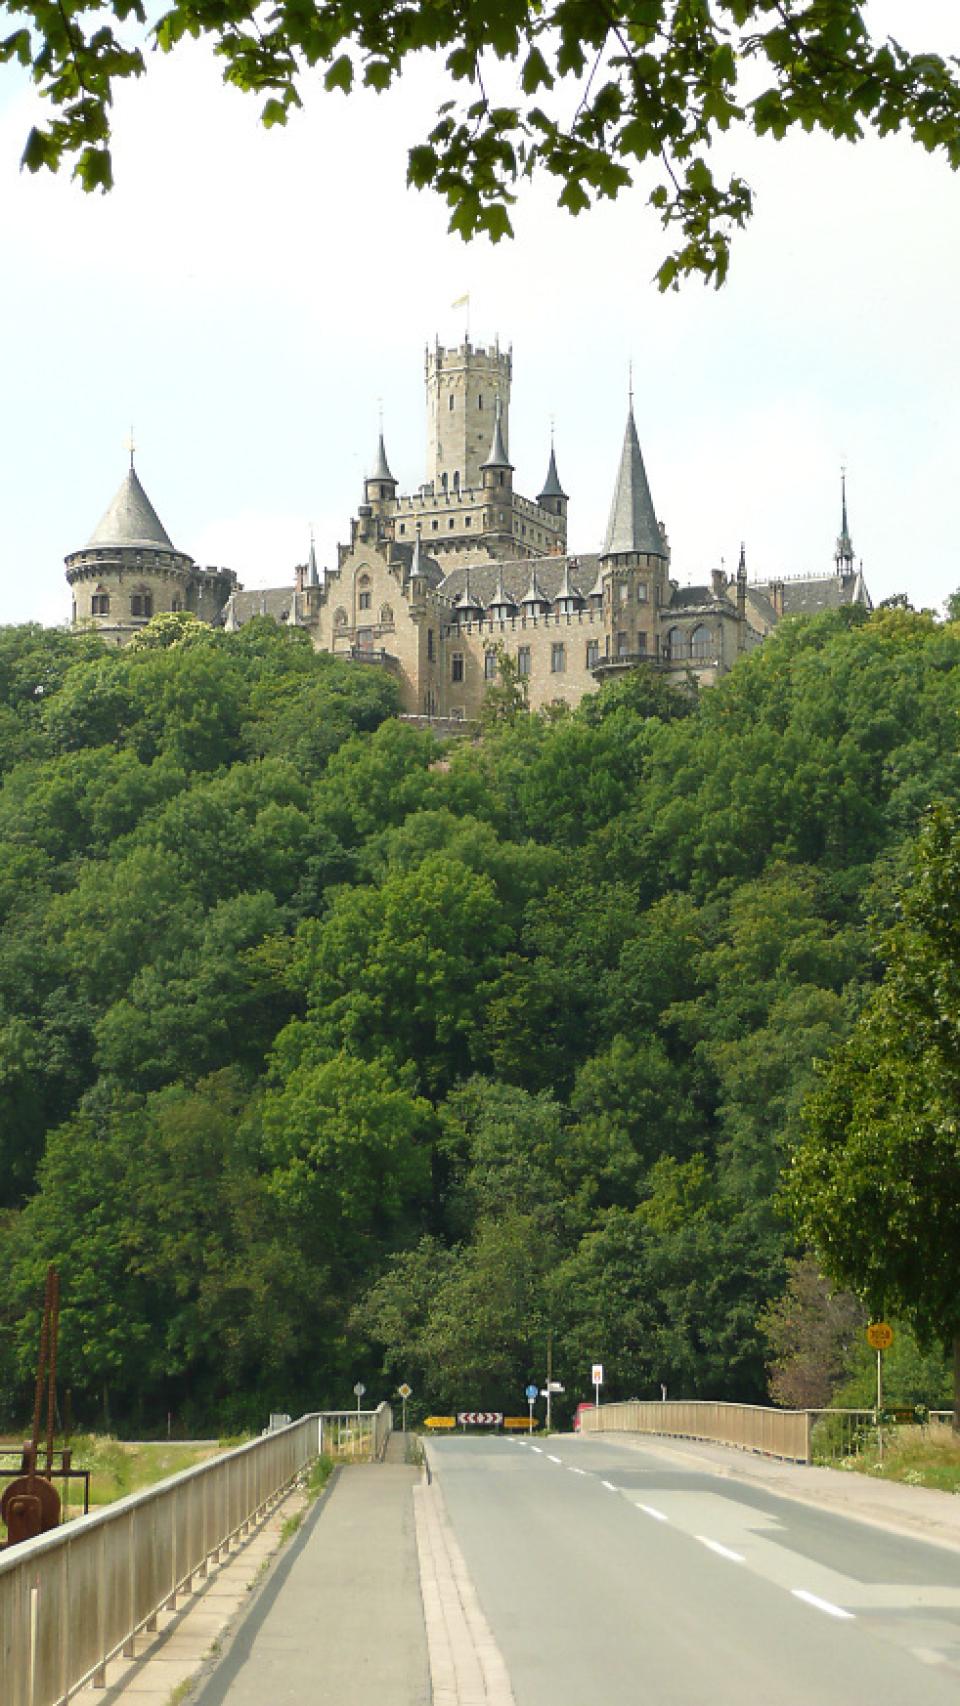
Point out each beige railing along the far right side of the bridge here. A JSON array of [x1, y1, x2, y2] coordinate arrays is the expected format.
[[580, 1399, 813, 1464]]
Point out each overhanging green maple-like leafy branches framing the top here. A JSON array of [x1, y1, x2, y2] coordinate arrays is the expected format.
[[0, 0, 960, 288]]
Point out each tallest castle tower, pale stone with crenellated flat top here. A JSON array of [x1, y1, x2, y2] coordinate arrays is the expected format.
[[426, 339, 513, 495]]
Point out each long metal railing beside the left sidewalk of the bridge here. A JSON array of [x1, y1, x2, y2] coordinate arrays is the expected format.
[[0, 1404, 392, 1706]]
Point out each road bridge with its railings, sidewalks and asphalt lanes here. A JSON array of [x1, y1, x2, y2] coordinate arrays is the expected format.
[[0, 1406, 960, 1706]]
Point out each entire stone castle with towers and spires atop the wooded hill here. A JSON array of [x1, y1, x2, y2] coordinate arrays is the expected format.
[[67, 339, 870, 722]]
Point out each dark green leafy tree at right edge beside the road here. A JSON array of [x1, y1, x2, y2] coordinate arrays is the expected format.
[[784, 807, 960, 1426]]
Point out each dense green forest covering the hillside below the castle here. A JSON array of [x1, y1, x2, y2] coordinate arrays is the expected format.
[[0, 607, 960, 1431]]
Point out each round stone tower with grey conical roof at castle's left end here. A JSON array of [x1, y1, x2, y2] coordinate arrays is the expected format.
[[65, 450, 237, 645]]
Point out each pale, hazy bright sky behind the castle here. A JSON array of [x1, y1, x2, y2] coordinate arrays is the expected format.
[[0, 0, 960, 624]]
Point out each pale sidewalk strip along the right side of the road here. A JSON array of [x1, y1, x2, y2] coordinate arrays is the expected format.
[[570, 1431, 960, 1547]]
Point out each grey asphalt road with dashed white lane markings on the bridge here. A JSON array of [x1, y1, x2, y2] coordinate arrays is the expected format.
[[431, 1436, 960, 1706]]
